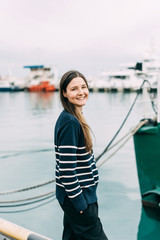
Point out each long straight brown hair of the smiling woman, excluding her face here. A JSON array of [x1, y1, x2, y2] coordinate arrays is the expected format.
[[60, 70, 92, 152]]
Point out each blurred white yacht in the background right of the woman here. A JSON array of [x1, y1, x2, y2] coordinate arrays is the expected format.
[[91, 51, 160, 91]]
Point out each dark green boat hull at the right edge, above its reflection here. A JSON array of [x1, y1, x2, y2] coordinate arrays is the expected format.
[[134, 123, 160, 208]]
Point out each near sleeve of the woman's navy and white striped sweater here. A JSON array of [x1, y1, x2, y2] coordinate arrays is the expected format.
[[58, 120, 87, 211]]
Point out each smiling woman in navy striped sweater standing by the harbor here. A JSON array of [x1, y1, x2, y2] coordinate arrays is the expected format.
[[54, 71, 107, 240]]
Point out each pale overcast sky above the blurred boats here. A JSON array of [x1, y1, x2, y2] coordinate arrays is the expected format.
[[0, 0, 160, 75]]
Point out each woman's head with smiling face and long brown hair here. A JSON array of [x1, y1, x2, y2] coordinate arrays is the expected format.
[[60, 71, 92, 151]]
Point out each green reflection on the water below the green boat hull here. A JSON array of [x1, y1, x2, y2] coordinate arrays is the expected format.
[[137, 207, 160, 240]]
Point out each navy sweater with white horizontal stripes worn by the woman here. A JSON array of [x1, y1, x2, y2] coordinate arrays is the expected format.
[[54, 110, 99, 211]]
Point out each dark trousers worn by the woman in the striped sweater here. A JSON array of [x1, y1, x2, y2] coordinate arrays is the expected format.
[[61, 197, 108, 240]]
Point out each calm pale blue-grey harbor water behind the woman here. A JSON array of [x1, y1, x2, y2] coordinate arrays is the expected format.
[[0, 92, 158, 240]]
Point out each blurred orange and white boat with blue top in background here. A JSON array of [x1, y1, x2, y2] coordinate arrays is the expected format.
[[24, 65, 55, 92]]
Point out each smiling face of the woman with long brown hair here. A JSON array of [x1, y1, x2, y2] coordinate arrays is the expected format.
[[63, 77, 89, 110]]
